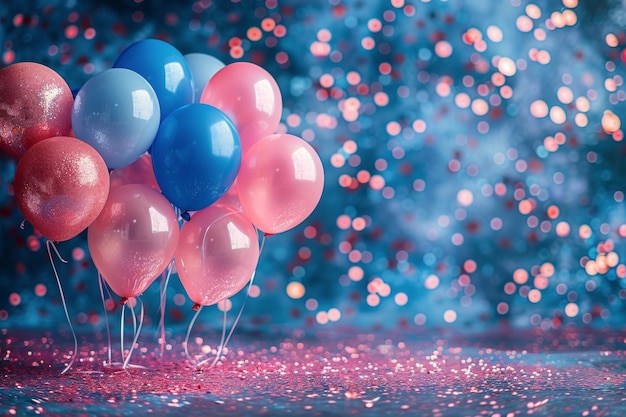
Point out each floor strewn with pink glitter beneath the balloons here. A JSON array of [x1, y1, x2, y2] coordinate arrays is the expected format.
[[0, 329, 626, 417]]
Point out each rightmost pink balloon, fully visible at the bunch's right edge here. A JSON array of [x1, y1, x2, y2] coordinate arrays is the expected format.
[[237, 134, 324, 234]]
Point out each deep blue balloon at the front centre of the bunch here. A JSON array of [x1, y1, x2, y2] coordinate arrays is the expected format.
[[151, 103, 241, 210]]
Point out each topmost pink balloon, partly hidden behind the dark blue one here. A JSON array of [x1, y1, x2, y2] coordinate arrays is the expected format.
[[200, 62, 283, 154]]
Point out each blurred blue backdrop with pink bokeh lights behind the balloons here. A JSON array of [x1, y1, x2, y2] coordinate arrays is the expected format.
[[0, 0, 626, 334]]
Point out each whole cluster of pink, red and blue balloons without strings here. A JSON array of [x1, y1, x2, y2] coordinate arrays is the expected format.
[[0, 39, 324, 306]]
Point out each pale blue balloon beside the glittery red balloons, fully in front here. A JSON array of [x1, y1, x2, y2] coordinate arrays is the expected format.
[[72, 68, 161, 169]]
